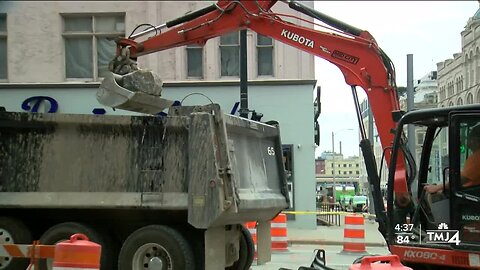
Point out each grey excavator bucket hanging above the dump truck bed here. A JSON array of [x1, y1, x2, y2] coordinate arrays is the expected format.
[[97, 72, 174, 114]]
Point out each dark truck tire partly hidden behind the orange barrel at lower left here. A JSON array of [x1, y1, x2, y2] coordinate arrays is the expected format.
[[38, 222, 116, 270]]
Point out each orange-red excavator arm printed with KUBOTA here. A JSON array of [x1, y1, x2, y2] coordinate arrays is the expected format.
[[111, 0, 409, 202]]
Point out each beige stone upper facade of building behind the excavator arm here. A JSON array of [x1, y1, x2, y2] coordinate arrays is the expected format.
[[0, 1, 314, 83]]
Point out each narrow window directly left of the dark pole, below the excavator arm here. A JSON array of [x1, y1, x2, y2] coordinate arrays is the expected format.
[[220, 32, 240, 76]]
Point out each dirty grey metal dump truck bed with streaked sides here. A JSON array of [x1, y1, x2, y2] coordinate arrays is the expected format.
[[0, 105, 288, 228]]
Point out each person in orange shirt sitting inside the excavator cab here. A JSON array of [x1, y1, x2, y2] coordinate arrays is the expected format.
[[424, 125, 480, 194]]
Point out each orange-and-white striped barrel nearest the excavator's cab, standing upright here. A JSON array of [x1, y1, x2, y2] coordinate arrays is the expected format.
[[342, 215, 367, 254]]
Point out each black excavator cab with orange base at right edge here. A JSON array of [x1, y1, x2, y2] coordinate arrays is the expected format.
[[387, 105, 480, 269]]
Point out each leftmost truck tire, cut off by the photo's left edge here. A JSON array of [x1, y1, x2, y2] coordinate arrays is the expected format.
[[0, 217, 33, 270]]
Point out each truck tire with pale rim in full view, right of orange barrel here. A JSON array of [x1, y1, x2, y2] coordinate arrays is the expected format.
[[118, 225, 195, 270]]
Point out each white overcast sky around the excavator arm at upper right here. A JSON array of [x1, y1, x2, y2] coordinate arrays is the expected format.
[[315, 1, 479, 156]]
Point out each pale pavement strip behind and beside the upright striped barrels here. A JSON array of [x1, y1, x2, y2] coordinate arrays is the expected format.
[[287, 219, 387, 247]]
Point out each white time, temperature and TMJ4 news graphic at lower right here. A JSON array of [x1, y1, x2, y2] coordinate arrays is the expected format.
[[395, 223, 461, 246]]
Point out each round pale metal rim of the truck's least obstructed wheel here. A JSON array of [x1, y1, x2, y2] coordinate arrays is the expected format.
[[132, 243, 173, 270]]
